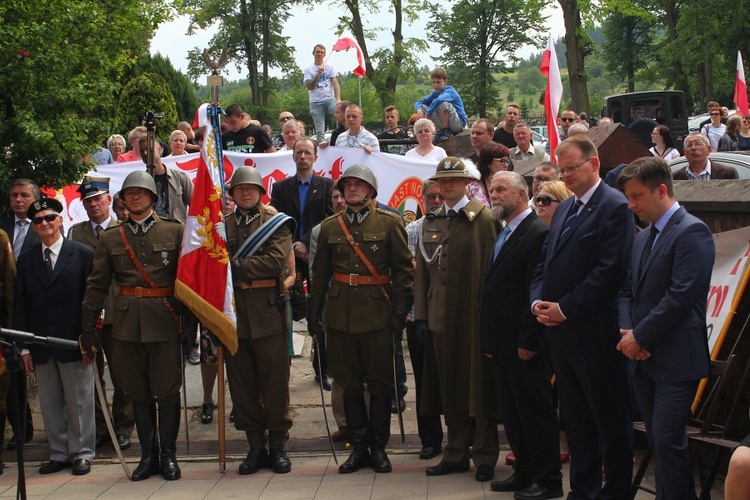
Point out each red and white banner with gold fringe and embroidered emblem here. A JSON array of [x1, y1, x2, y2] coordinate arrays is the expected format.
[[175, 104, 237, 354]]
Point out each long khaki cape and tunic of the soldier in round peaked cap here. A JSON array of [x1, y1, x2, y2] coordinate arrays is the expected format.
[[414, 200, 500, 418]]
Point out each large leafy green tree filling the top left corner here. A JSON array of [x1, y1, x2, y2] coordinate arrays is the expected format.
[[0, 0, 170, 192]]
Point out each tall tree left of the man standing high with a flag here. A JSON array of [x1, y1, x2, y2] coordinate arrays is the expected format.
[[185, 0, 307, 121]]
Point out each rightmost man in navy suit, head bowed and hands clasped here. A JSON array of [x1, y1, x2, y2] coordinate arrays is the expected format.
[[617, 157, 715, 499]]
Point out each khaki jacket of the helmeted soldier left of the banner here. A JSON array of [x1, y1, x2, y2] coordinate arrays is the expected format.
[[83, 212, 185, 342]]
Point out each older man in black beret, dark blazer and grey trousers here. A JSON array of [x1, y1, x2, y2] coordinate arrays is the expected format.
[[14, 198, 96, 475]]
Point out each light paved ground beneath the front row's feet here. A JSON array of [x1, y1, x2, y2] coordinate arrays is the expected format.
[[0, 324, 724, 500]]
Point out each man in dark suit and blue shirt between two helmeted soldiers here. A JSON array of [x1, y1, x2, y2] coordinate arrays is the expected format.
[[271, 137, 333, 391]]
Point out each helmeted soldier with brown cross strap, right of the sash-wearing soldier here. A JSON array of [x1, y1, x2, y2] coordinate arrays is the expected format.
[[307, 165, 414, 473]]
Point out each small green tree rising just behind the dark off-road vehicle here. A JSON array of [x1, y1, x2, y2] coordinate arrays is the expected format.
[[602, 8, 656, 92]]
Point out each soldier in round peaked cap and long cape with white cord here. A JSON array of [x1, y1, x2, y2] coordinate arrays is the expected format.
[[414, 156, 499, 481]]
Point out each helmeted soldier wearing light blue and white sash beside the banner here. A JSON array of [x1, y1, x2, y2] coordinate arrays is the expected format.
[[225, 167, 294, 474]]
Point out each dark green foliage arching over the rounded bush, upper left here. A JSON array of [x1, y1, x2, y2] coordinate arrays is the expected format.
[[122, 53, 199, 123]]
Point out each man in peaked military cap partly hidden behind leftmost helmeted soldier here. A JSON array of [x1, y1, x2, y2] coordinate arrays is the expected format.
[[68, 175, 135, 450]]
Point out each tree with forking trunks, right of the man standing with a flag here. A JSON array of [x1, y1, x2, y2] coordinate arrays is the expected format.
[[331, 0, 427, 108]]
